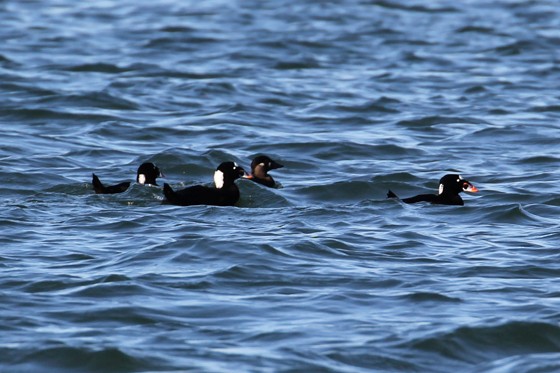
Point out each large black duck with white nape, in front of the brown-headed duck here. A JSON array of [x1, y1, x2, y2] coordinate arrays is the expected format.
[[163, 162, 246, 206]]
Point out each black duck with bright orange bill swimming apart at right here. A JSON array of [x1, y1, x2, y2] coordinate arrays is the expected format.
[[387, 174, 478, 206]]
